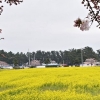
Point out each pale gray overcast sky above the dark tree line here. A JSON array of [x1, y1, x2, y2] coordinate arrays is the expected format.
[[0, 0, 100, 53]]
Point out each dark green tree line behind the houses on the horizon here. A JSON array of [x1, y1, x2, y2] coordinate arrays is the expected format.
[[0, 47, 100, 65]]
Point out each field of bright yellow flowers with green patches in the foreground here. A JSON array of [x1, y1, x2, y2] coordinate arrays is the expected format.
[[0, 67, 100, 100]]
